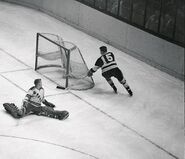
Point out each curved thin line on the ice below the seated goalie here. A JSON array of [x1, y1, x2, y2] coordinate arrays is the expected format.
[[0, 134, 99, 159]]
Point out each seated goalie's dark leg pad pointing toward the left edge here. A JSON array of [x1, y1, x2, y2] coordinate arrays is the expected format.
[[3, 103, 21, 118]]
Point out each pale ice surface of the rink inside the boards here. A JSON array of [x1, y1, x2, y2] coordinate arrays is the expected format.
[[0, 2, 184, 159]]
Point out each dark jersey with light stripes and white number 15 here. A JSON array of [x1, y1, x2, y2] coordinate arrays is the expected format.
[[93, 52, 117, 73]]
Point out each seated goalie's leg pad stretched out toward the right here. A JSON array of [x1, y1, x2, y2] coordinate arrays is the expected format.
[[39, 106, 69, 120]]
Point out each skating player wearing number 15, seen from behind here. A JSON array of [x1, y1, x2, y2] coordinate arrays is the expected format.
[[87, 46, 133, 96]]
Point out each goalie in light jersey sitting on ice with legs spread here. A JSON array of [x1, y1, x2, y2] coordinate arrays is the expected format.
[[3, 79, 69, 120]]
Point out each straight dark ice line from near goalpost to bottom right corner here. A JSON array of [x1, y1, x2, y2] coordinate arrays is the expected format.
[[69, 91, 180, 159]]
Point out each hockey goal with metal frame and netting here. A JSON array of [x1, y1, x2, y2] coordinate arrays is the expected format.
[[35, 33, 94, 90]]
